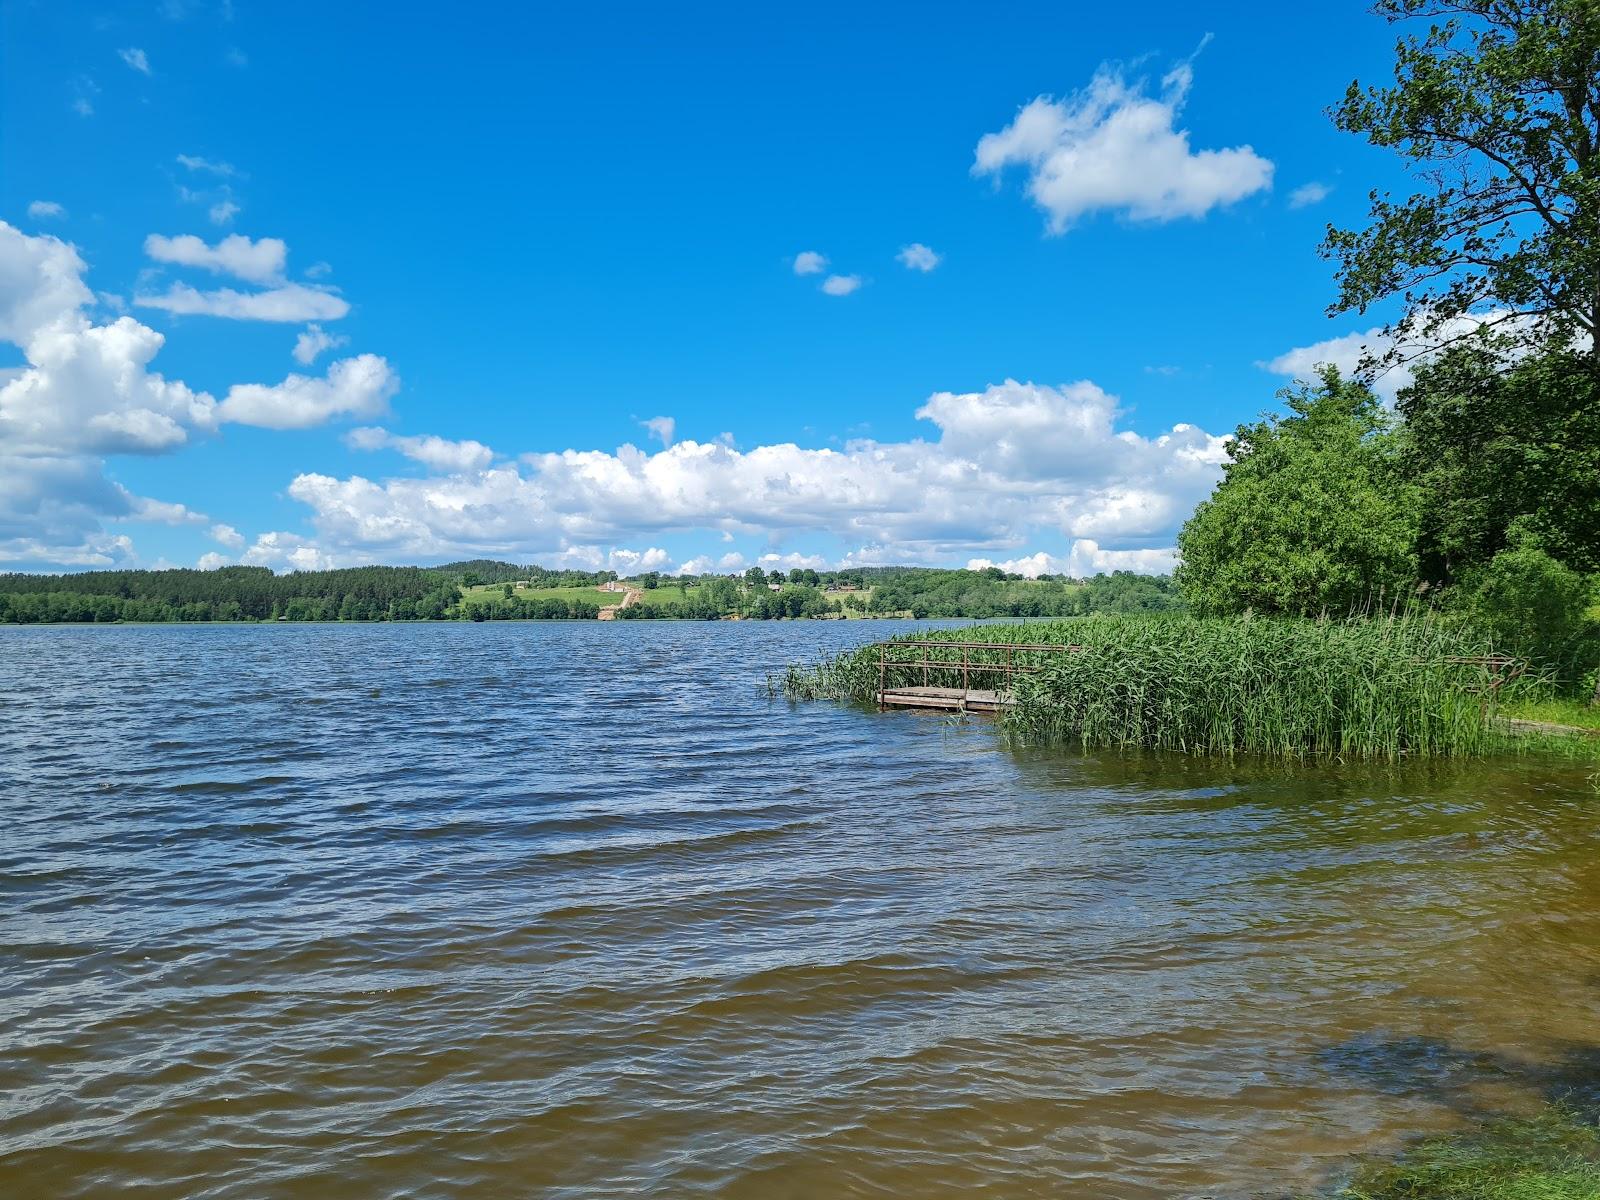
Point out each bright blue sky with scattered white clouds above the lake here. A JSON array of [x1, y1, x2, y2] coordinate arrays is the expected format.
[[0, 0, 1420, 571]]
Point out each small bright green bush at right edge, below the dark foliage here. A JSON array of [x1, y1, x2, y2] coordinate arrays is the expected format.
[[1462, 518, 1600, 682]]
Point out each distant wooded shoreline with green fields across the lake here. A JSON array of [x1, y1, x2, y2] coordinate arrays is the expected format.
[[0, 560, 1182, 624]]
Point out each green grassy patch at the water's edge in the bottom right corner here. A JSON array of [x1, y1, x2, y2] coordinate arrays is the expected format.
[[1338, 1107, 1600, 1200]]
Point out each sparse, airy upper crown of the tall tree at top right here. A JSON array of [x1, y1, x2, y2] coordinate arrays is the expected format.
[[1323, 0, 1600, 373]]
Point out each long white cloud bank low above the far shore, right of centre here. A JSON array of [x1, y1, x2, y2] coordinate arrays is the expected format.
[[265, 381, 1224, 568]]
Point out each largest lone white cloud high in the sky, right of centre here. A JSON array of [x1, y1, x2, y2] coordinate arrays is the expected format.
[[973, 54, 1272, 234]]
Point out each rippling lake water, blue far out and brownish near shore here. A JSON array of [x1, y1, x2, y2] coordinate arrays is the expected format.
[[0, 622, 1600, 1200]]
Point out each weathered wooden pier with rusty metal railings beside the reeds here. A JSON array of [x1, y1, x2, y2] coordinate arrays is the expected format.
[[877, 640, 1082, 712]]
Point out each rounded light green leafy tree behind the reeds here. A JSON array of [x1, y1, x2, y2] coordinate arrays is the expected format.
[[1178, 368, 1418, 614]]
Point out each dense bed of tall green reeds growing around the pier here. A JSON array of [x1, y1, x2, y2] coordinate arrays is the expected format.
[[778, 616, 1568, 760]]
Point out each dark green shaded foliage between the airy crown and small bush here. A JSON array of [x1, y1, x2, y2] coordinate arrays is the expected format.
[[1398, 347, 1600, 582]]
